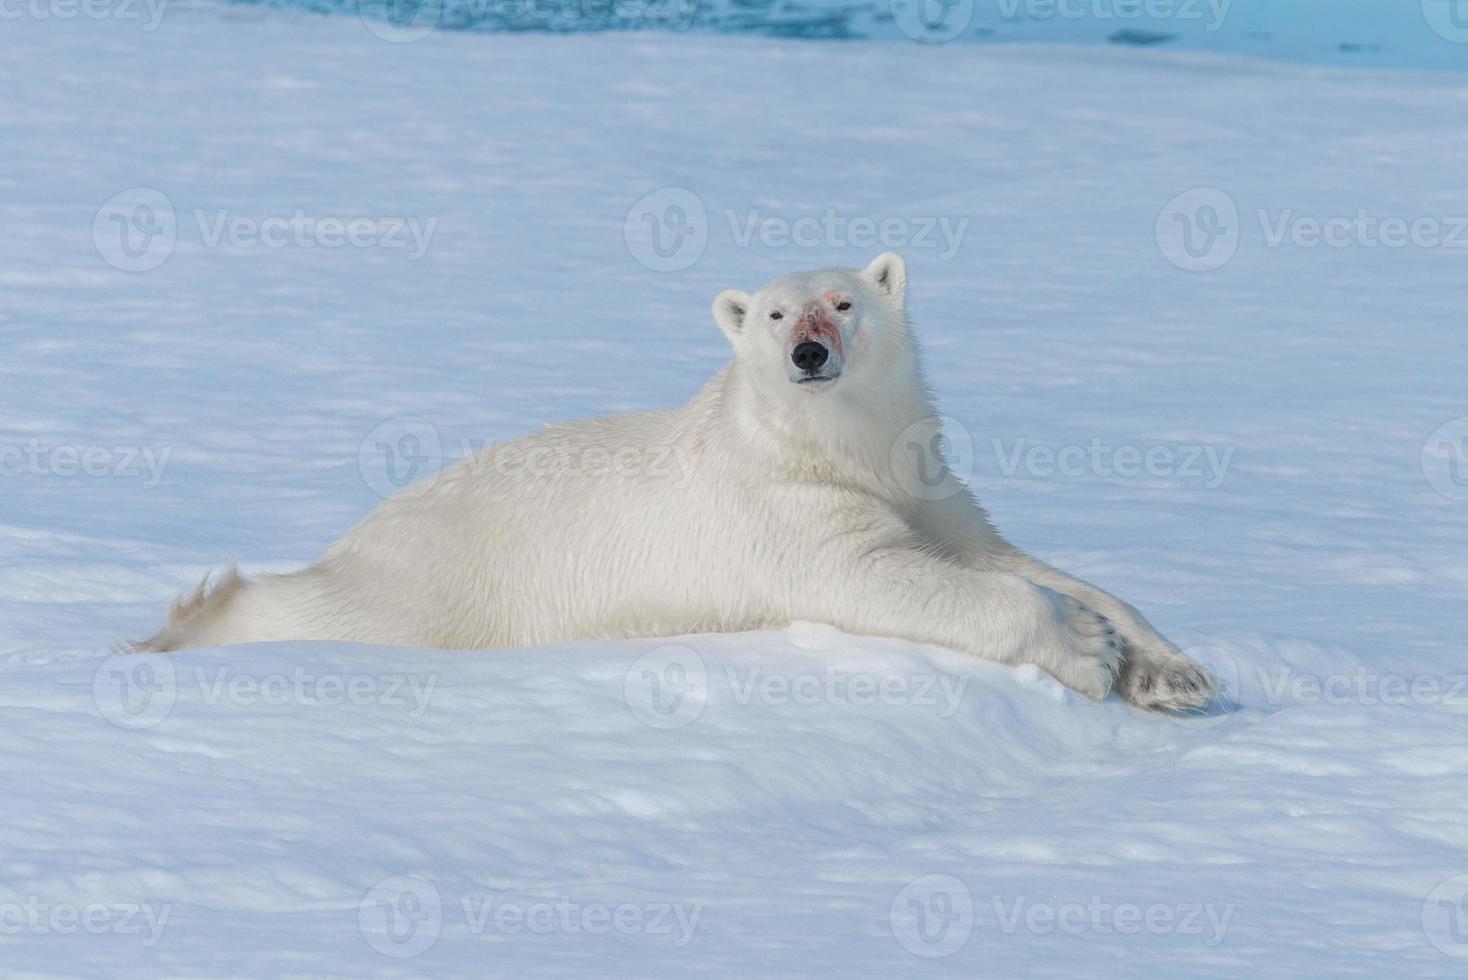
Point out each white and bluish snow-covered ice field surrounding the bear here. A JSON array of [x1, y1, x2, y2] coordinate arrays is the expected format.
[[0, 6, 1468, 977]]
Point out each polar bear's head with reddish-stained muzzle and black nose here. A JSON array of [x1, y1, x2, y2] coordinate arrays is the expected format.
[[713, 252, 918, 406]]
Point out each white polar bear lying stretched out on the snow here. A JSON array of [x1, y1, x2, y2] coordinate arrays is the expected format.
[[138, 254, 1214, 710]]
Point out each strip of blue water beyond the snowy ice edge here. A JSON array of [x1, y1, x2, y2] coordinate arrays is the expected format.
[[235, 0, 1468, 70]]
